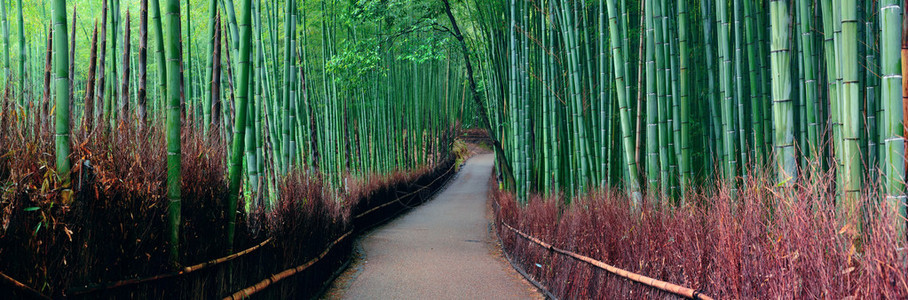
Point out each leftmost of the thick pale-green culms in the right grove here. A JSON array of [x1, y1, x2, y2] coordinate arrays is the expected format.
[[769, 0, 798, 186]]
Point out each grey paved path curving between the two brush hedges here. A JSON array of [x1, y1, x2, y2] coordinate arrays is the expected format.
[[325, 154, 540, 299]]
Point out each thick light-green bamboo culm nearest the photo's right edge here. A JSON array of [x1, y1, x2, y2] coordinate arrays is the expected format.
[[880, 0, 908, 236]]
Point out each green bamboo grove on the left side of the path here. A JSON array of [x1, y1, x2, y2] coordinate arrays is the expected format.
[[0, 0, 472, 260]]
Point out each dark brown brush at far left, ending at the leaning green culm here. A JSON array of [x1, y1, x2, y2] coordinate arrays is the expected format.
[[0, 118, 238, 293]]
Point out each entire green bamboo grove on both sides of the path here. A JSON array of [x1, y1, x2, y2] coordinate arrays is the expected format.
[[7, 0, 908, 266]]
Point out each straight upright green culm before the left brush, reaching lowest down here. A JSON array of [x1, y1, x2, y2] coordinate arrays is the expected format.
[[163, 0, 182, 264]]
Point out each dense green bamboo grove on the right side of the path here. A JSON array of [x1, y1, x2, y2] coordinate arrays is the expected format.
[[470, 0, 908, 225]]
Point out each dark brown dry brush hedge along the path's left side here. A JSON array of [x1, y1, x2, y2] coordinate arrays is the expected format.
[[0, 114, 446, 297]]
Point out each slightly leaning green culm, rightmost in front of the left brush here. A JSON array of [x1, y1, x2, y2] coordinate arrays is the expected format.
[[227, 0, 252, 253]]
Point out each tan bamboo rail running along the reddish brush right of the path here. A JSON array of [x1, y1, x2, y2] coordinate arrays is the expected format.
[[501, 222, 713, 300]]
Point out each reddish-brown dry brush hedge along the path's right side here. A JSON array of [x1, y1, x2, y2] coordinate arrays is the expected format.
[[491, 168, 908, 299]]
